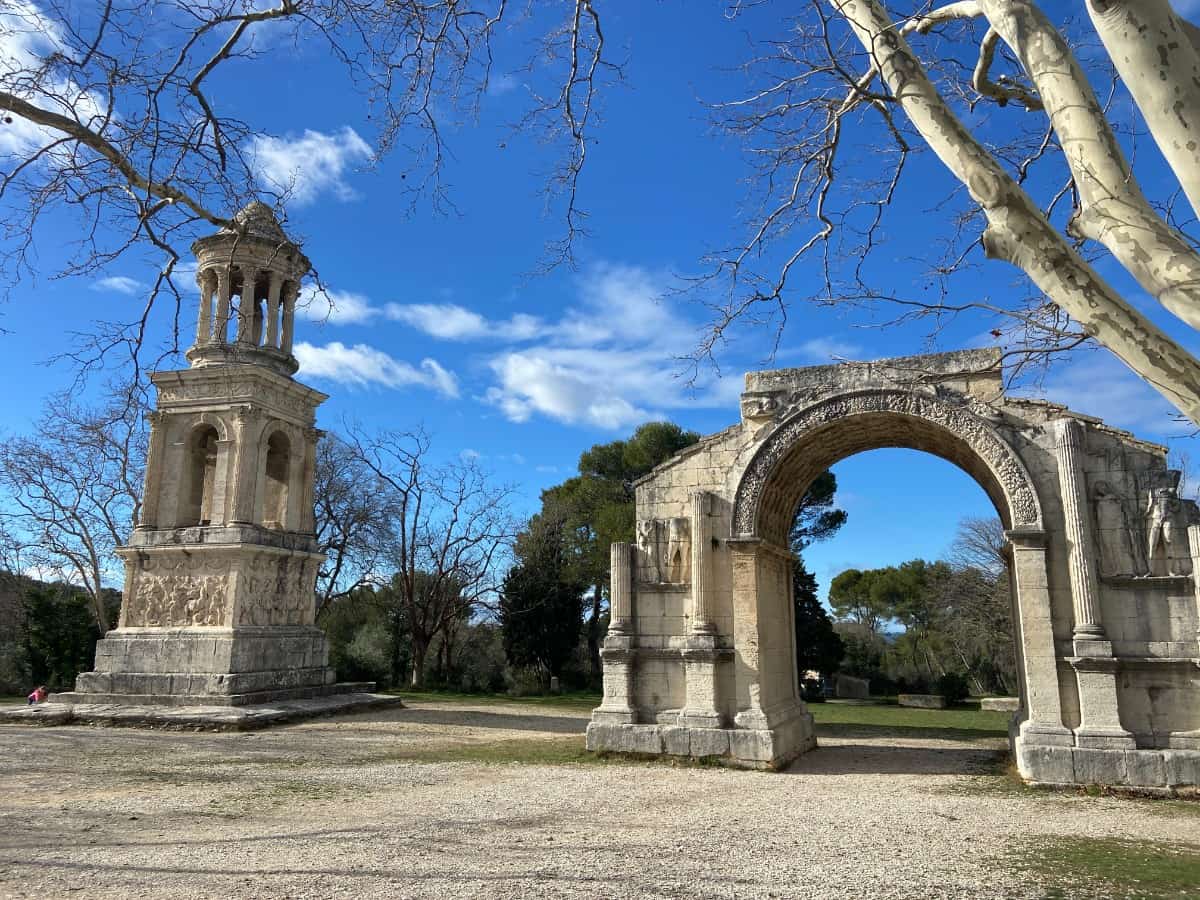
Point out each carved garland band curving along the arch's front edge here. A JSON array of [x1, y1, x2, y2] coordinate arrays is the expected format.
[[733, 390, 1042, 535]]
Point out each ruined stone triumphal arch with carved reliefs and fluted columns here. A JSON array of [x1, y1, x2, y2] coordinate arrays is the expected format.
[[588, 350, 1200, 787]]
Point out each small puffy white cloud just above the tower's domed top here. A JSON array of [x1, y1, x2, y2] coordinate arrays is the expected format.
[[250, 126, 371, 205]]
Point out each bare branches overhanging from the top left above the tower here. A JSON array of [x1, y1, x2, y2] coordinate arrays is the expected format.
[[0, 0, 609, 365]]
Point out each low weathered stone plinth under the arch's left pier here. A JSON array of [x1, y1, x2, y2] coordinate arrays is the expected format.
[[587, 713, 817, 769]]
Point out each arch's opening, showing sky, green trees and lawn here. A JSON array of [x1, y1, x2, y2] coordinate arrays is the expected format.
[[790, 449, 1020, 772]]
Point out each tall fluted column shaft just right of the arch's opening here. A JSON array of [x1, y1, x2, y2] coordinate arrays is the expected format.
[[1055, 419, 1112, 656]]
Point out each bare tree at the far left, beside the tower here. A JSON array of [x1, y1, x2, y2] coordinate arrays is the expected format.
[[0, 389, 148, 631]]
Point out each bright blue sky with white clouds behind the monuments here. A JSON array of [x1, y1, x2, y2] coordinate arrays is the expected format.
[[0, 0, 1198, 600]]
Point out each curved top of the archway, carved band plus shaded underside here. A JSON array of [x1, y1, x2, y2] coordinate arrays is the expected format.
[[731, 390, 1043, 546]]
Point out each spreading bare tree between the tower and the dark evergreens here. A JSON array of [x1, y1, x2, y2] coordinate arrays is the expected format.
[[348, 431, 518, 686]]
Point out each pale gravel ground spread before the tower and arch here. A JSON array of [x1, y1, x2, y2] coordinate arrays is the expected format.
[[0, 703, 1200, 900]]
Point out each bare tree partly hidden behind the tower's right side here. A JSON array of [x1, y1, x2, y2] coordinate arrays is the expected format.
[[313, 434, 389, 616]]
